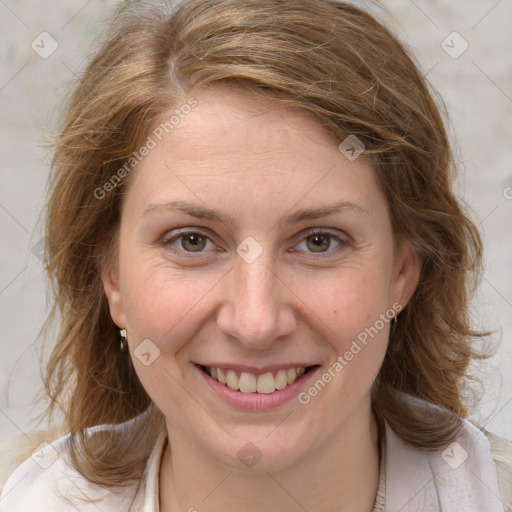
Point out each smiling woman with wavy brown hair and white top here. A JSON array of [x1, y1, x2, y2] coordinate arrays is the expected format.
[[0, 0, 512, 512]]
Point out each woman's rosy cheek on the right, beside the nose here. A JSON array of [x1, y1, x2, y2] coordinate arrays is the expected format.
[[290, 258, 394, 396]]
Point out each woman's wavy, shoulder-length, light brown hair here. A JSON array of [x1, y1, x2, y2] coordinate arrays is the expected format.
[[37, 0, 486, 486]]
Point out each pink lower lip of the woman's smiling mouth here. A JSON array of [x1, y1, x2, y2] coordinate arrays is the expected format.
[[196, 366, 320, 411]]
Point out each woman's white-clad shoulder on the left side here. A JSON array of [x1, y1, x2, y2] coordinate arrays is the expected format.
[[0, 431, 136, 512]]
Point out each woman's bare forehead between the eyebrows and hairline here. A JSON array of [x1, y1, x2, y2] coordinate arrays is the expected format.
[[123, 87, 376, 216]]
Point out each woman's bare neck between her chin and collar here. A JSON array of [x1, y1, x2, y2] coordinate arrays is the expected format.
[[160, 407, 379, 512]]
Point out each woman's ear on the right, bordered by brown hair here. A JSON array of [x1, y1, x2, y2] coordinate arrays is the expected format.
[[391, 240, 422, 309]]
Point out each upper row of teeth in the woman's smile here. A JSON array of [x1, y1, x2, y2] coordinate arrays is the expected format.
[[206, 367, 306, 393]]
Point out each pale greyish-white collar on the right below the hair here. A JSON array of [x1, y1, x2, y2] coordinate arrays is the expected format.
[[385, 397, 504, 512]]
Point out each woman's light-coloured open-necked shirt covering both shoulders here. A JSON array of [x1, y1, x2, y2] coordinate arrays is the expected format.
[[0, 406, 512, 512]]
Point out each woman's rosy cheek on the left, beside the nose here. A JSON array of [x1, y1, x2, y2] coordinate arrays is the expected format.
[[119, 259, 222, 417]]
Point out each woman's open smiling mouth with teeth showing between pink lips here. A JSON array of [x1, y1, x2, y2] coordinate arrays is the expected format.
[[196, 365, 319, 408]]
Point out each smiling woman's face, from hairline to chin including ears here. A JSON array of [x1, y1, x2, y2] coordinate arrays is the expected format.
[[103, 88, 418, 469]]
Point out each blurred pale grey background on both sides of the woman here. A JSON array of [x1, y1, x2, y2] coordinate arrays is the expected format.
[[0, 0, 512, 439]]
